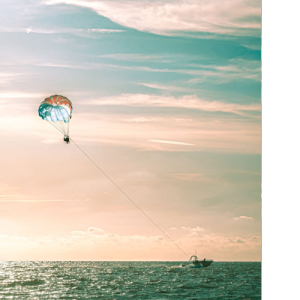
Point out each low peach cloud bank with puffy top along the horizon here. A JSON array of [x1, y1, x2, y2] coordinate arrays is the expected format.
[[0, 226, 261, 260]]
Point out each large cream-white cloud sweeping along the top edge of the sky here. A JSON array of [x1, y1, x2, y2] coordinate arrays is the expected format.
[[44, 0, 261, 36]]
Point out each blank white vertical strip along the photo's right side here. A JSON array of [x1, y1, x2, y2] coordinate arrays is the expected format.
[[262, 0, 300, 300]]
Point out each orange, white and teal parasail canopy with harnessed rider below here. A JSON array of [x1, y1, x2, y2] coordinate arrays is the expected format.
[[39, 95, 73, 144]]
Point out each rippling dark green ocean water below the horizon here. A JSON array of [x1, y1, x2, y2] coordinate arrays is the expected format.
[[0, 261, 261, 300]]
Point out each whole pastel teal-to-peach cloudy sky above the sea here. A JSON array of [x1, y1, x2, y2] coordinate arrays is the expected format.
[[0, 0, 261, 261]]
